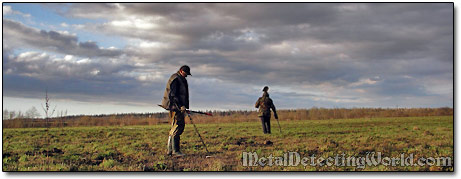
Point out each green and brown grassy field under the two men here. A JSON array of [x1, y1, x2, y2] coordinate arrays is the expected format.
[[2, 116, 453, 171]]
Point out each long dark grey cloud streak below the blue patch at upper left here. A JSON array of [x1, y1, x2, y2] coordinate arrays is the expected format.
[[3, 19, 121, 57]]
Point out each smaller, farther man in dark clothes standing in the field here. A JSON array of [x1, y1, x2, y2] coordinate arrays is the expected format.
[[255, 86, 279, 134]]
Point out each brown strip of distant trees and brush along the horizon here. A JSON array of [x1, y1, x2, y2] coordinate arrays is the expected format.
[[2, 107, 453, 128]]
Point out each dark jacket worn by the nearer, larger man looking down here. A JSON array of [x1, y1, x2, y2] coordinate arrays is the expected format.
[[162, 72, 189, 110]]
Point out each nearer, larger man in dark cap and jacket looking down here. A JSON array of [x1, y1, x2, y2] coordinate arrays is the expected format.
[[162, 65, 191, 156]]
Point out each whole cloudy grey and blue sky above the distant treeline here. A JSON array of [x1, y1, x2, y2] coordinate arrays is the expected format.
[[2, 3, 453, 114]]
